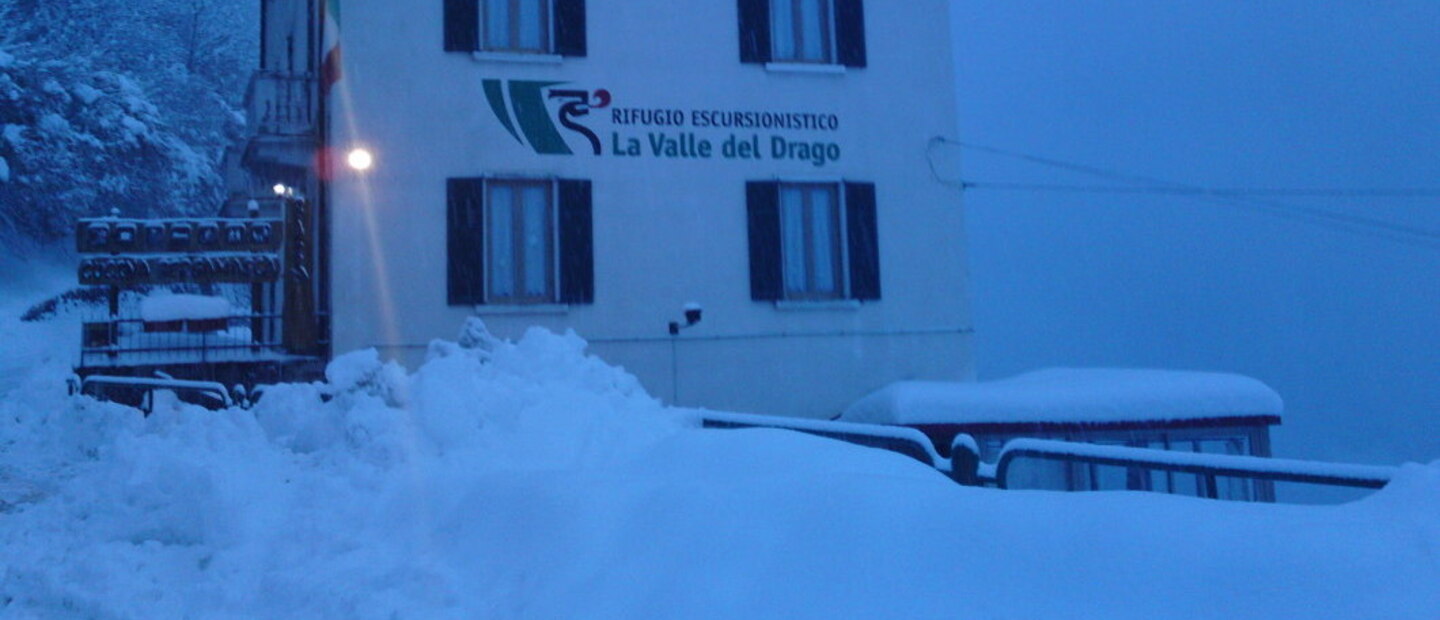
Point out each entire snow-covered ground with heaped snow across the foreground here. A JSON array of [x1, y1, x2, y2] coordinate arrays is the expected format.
[[0, 273, 1440, 619]]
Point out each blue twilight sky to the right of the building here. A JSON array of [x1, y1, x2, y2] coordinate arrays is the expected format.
[[953, 0, 1440, 463]]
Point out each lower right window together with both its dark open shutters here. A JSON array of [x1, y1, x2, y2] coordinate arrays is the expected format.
[[746, 181, 880, 302]]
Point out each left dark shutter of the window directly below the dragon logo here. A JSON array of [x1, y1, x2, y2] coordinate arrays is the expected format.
[[445, 178, 485, 305]]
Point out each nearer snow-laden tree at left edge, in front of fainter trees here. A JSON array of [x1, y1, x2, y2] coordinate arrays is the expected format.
[[0, 45, 219, 242]]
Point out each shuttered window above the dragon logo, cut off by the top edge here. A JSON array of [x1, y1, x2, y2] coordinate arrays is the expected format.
[[445, 0, 588, 56]]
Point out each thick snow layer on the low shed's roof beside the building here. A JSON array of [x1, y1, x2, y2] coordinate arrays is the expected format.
[[840, 368, 1284, 424]]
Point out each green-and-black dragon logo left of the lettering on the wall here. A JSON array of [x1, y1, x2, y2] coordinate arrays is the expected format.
[[484, 79, 611, 155]]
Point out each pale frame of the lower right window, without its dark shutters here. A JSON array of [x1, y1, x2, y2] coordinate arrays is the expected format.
[[776, 181, 850, 304]]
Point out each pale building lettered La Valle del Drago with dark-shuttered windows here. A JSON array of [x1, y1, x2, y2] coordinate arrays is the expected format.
[[245, 0, 972, 416]]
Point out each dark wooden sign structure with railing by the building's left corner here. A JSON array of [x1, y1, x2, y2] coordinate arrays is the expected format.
[[76, 197, 328, 397]]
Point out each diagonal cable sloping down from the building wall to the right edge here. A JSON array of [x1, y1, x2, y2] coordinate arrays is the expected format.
[[937, 138, 1440, 249]]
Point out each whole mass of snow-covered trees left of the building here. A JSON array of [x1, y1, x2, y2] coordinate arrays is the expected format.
[[0, 0, 258, 250]]
